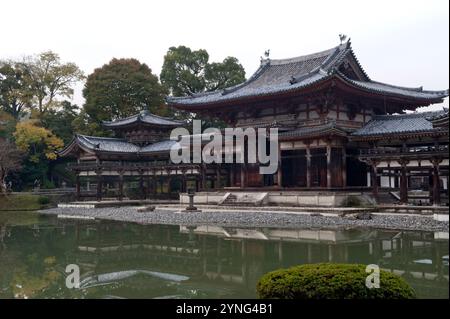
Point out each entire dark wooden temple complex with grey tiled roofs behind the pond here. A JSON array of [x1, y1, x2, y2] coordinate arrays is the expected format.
[[61, 41, 449, 204]]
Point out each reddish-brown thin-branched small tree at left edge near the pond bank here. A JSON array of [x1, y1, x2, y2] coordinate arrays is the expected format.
[[0, 137, 23, 194]]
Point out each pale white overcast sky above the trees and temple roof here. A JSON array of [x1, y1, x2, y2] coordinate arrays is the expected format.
[[0, 0, 449, 109]]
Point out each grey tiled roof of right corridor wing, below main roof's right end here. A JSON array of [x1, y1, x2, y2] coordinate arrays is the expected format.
[[351, 111, 444, 136]]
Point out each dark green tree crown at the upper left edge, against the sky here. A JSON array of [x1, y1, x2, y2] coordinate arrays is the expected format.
[[0, 61, 32, 119]]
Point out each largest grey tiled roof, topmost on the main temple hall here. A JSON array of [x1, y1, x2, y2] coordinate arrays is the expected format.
[[166, 41, 448, 109]]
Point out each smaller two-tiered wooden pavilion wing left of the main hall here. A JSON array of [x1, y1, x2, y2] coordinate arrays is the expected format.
[[59, 111, 213, 200]]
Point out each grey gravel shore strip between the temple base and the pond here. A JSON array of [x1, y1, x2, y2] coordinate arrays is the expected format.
[[40, 207, 449, 232]]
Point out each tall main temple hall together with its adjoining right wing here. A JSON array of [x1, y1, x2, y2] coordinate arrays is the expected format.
[[167, 41, 449, 202]]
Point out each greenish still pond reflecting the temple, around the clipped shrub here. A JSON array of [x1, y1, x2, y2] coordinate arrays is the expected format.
[[0, 212, 449, 298]]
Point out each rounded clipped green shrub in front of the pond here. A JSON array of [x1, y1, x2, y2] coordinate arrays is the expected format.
[[256, 264, 415, 299]]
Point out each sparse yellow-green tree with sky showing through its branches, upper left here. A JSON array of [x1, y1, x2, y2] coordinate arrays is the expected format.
[[21, 51, 84, 114]]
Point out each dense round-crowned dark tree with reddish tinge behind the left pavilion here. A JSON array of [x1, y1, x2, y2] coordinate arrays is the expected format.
[[83, 59, 167, 127]]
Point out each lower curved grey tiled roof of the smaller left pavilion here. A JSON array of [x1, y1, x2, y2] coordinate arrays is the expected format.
[[59, 134, 178, 157]]
